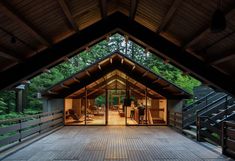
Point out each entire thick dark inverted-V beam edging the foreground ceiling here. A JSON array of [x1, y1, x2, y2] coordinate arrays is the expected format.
[[0, 12, 235, 97]]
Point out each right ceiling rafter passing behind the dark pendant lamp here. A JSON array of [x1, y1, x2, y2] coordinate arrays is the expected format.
[[183, 2, 235, 49]]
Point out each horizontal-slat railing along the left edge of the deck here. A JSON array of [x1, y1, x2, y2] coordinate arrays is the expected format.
[[0, 110, 63, 147]]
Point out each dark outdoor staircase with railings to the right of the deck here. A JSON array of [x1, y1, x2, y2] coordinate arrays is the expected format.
[[183, 89, 235, 145]]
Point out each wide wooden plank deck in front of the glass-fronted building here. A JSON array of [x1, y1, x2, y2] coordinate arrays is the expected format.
[[4, 126, 233, 161]]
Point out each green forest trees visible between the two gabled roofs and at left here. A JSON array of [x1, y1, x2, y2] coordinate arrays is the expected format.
[[0, 34, 201, 119]]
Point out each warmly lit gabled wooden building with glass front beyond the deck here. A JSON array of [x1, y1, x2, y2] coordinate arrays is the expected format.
[[42, 52, 191, 125]]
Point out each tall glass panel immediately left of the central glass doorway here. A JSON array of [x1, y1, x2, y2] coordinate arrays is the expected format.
[[86, 89, 106, 125]]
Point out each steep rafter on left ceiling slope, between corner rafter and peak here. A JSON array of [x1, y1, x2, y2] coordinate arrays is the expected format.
[[57, 0, 79, 32]]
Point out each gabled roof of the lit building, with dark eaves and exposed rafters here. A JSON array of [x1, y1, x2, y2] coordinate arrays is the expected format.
[[42, 52, 191, 99]]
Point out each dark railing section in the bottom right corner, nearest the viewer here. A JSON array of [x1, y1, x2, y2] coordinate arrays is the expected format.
[[222, 121, 235, 158]]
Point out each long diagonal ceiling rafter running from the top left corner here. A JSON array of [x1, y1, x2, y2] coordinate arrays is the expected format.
[[0, 1, 50, 46]]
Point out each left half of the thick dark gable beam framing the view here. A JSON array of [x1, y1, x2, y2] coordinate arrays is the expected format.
[[0, 14, 118, 89]]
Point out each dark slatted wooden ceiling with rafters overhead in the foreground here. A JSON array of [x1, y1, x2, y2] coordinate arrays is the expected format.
[[0, 0, 235, 94]]
